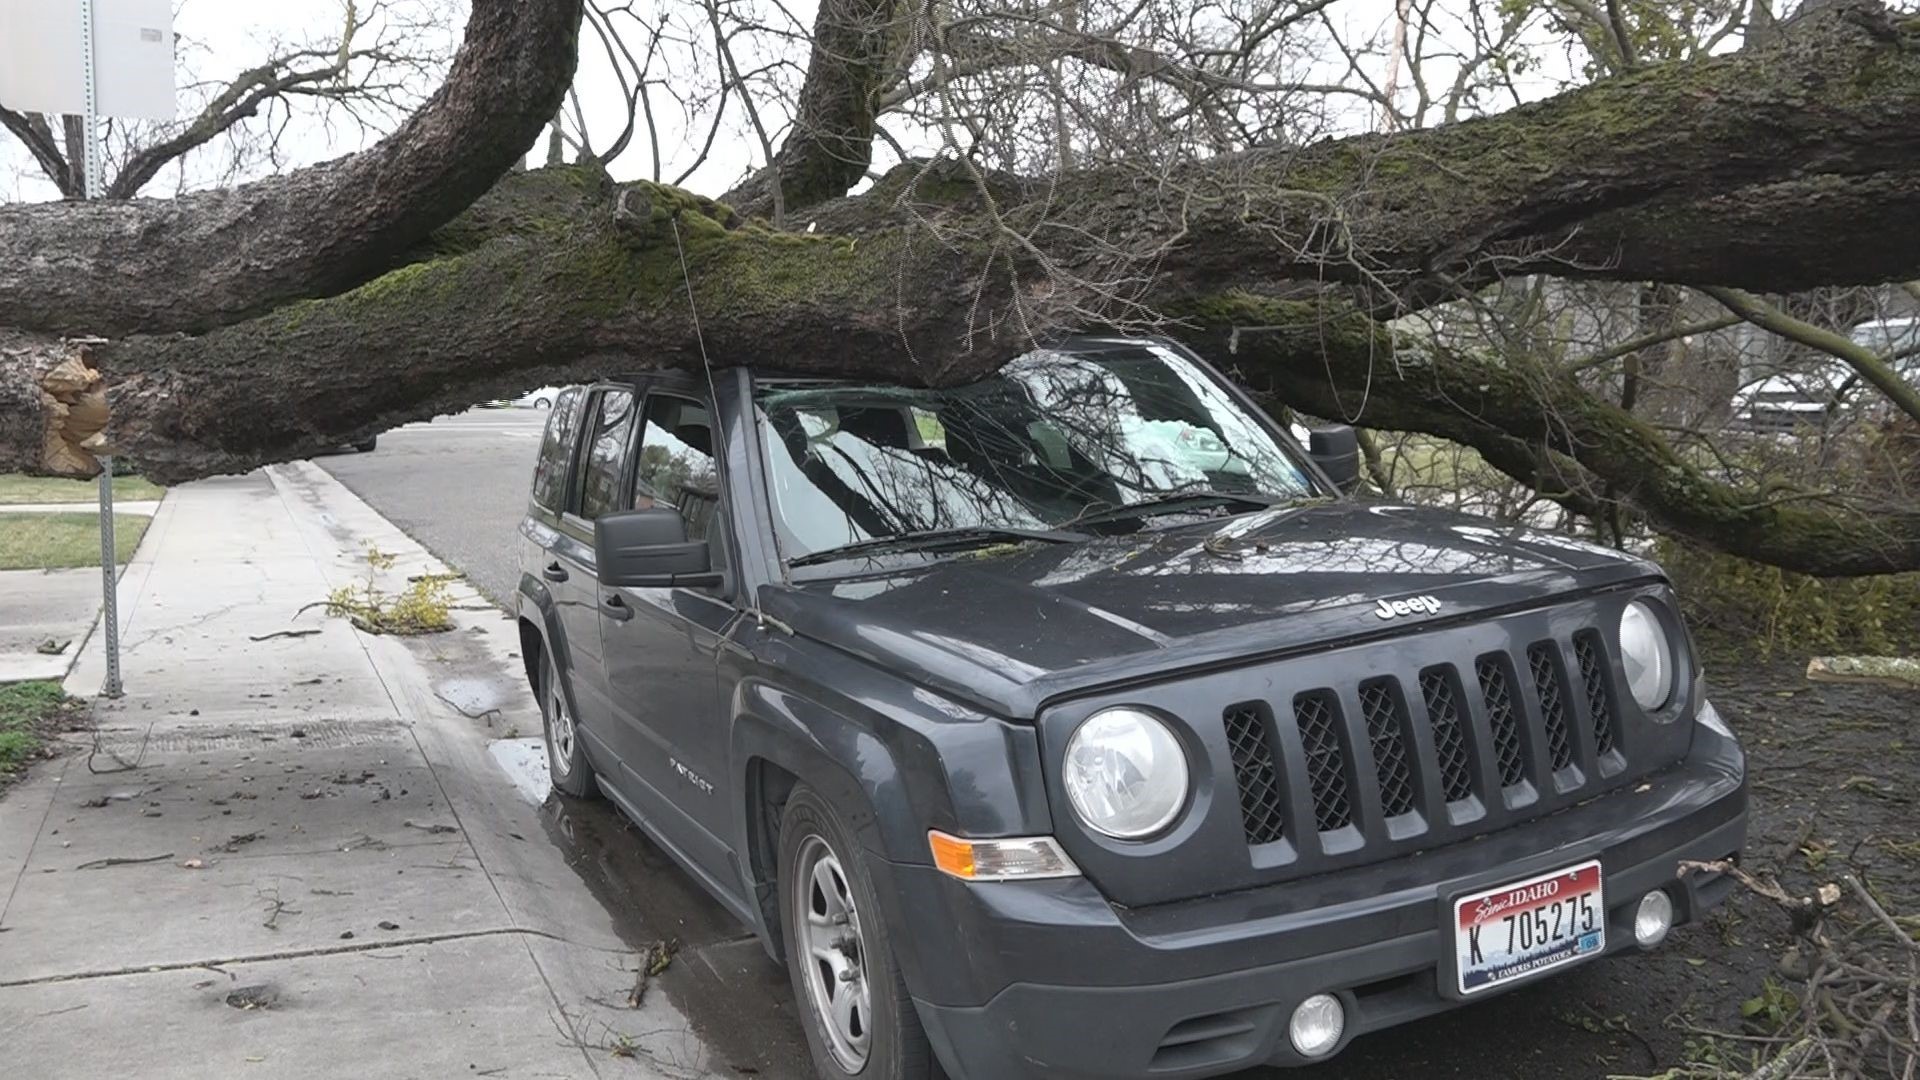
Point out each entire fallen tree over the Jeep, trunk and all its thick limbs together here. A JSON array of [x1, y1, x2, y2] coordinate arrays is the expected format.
[[0, 0, 1920, 573]]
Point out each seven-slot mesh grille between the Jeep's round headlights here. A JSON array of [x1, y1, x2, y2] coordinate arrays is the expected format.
[[1223, 630, 1624, 846]]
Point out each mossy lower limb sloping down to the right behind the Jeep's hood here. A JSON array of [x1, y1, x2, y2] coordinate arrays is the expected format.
[[1179, 294, 1920, 575]]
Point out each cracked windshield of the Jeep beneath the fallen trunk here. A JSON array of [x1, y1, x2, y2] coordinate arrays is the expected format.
[[756, 346, 1313, 559]]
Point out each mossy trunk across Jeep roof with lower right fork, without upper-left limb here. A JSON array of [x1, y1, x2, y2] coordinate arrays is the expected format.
[[11, 6, 1920, 573]]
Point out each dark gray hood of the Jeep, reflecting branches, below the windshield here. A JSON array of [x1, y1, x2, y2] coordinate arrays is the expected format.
[[762, 502, 1659, 717]]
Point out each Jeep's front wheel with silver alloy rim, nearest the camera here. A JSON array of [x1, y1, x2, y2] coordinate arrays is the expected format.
[[780, 786, 939, 1080]]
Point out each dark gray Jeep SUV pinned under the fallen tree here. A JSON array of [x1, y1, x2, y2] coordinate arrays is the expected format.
[[518, 338, 1747, 1080]]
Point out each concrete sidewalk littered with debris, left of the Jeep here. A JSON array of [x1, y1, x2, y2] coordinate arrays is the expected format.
[[0, 465, 726, 1078]]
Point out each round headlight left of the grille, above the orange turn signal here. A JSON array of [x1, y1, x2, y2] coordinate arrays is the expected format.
[[1062, 709, 1187, 840]]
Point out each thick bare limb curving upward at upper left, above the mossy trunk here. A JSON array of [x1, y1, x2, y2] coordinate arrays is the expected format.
[[0, 0, 582, 336]]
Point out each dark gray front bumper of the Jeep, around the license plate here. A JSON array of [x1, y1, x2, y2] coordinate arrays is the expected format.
[[889, 705, 1747, 1080]]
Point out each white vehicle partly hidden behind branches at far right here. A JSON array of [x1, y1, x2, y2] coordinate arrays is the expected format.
[[1734, 317, 1920, 434]]
